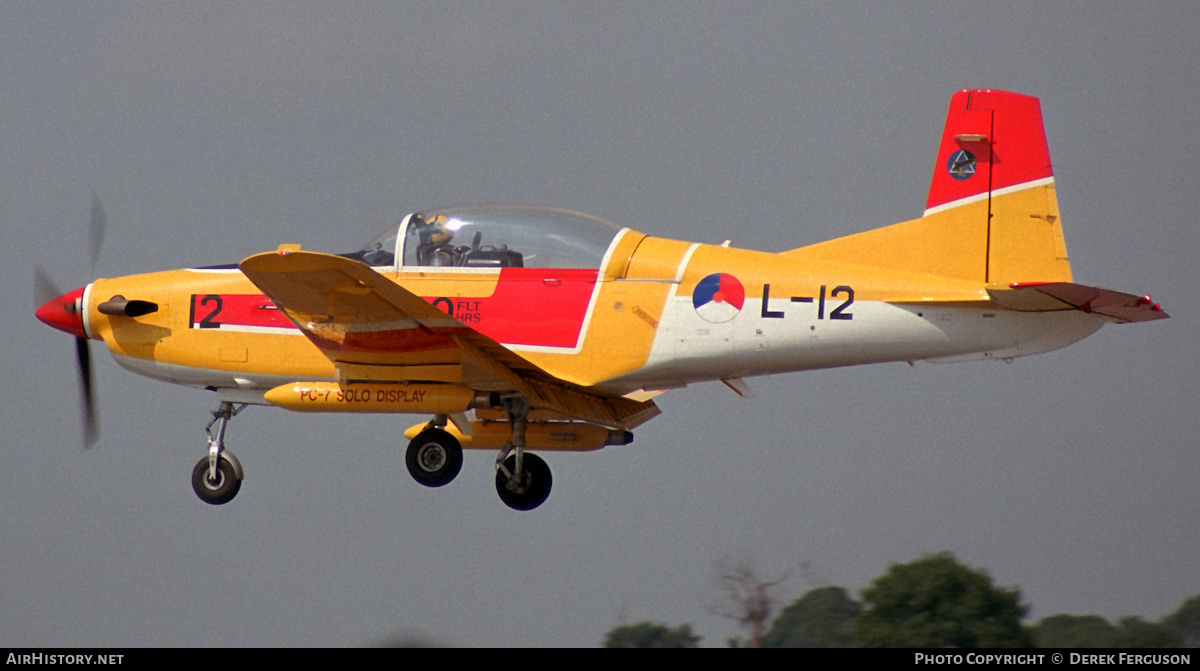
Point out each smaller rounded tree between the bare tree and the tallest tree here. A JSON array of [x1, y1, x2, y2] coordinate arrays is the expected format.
[[762, 586, 863, 648]]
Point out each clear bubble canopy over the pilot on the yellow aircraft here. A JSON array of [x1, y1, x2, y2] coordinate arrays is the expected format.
[[346, 205, 622, 268]]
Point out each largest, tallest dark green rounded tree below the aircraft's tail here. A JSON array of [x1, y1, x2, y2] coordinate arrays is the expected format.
[[854, 552, 1032, 648]]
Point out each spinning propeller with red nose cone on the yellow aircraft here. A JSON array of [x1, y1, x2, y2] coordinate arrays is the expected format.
[[34, 193, 108, 449]]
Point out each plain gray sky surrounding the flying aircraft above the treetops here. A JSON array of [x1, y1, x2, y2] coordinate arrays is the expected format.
[[0, 1, 1200, 646]]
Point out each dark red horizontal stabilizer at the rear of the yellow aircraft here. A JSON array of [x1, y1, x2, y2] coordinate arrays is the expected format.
[[988, 282, 1170, 324]]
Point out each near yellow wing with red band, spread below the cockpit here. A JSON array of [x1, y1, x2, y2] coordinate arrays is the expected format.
[[239, 250, 659, 430]]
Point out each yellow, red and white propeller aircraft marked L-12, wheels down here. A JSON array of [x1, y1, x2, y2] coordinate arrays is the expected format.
[[37, 90, 1166, 510]]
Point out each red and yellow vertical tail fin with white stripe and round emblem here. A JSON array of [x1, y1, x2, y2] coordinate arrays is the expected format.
[[788, 89, 1070, 283]]
